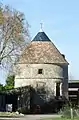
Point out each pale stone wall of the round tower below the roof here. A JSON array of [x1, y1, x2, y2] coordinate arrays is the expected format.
[[15, 64, 68, 98]]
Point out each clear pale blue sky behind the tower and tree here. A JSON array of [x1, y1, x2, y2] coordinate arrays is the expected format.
[[1, 0, 79, 83]]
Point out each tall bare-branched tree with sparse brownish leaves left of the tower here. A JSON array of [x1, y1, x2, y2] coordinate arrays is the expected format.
[[0, 4, 29, 67]]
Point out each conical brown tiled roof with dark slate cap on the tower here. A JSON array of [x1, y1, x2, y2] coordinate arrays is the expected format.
[[19, 32, 68, 64]]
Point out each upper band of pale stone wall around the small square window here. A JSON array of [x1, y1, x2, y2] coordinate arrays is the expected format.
[[16, 64, 63, 79]]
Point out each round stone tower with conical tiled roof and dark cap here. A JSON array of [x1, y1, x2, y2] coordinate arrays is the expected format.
[[15, 28, 68, 98]]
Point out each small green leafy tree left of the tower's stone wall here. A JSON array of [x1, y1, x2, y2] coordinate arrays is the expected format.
[[4, 75, 15, 90]]
